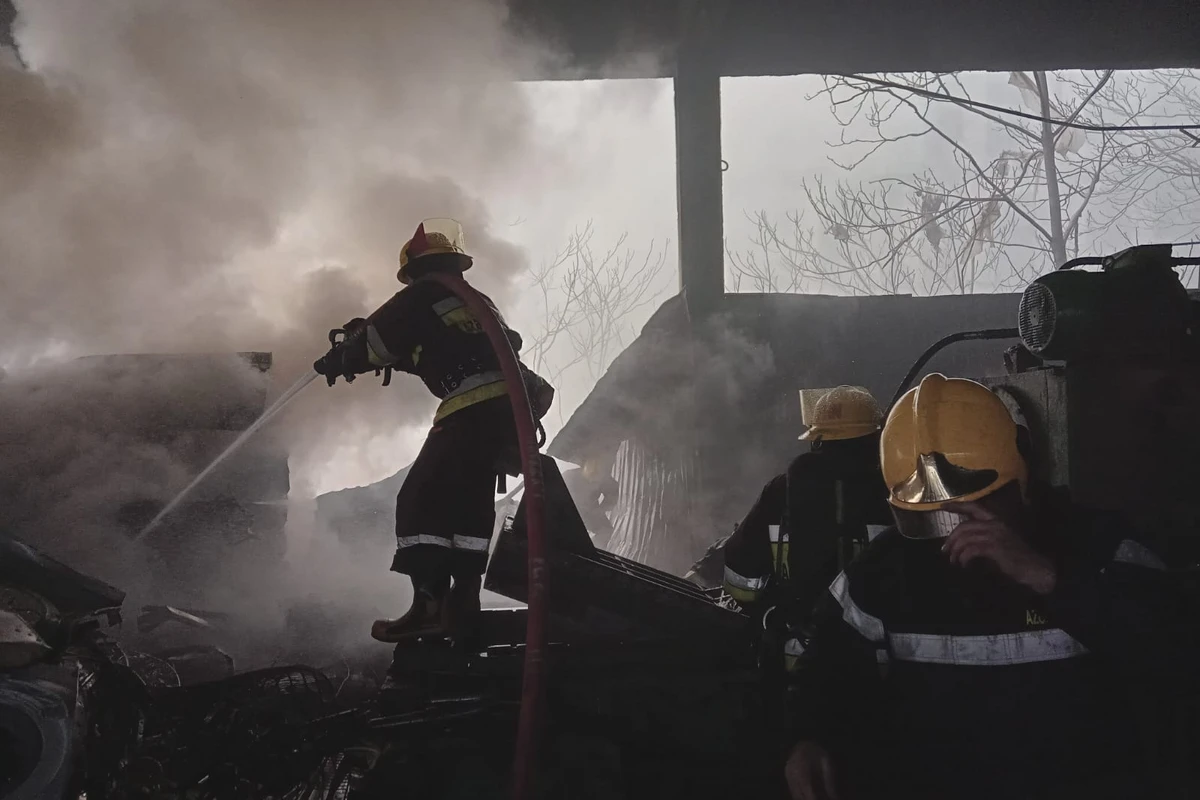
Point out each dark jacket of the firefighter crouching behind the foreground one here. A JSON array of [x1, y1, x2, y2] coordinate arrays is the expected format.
[[725, 437, 892, 618]]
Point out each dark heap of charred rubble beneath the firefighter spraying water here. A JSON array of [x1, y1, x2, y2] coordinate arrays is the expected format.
[[0, 459, 768, 800]]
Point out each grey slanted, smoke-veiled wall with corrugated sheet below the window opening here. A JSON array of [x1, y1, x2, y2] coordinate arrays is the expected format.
[[548, 294, 1018, 575]]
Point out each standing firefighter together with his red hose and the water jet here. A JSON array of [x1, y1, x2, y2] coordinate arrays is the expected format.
[[96, 219, 554, 798]]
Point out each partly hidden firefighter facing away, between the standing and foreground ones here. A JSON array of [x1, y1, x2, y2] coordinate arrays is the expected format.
[[724, 386, 888, 669]]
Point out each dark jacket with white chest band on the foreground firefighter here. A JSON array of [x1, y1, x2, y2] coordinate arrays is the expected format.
[[792, 506, 1198, 798]]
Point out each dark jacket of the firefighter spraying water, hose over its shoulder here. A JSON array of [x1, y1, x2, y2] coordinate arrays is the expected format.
[[350, 281, 553, 422]]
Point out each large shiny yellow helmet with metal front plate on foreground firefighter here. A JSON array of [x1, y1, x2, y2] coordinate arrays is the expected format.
[[880, 373, 1028, 511]]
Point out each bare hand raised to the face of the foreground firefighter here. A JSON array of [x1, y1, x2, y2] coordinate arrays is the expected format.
[[942, 503, 1058, 595]]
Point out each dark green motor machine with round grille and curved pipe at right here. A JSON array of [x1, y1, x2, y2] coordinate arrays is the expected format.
[[896, 245, 1200, 566]]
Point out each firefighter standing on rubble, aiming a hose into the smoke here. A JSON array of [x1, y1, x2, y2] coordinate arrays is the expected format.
[[314, 219, 553, 642]]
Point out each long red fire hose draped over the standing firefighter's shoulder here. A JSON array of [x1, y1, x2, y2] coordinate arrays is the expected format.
[[421, 272, 546, 800]]
